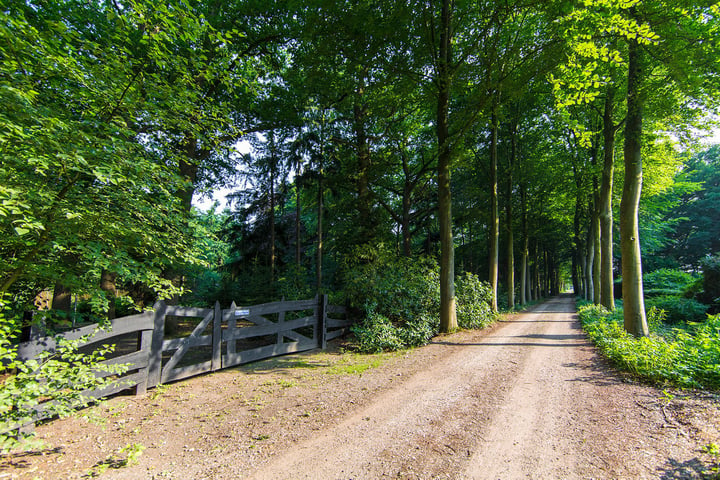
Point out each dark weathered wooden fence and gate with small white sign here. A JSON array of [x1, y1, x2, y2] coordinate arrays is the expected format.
[[11, 295, 352, 428]]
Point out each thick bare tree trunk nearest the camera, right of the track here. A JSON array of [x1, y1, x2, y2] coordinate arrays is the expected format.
[[620, 40, 648, 336]]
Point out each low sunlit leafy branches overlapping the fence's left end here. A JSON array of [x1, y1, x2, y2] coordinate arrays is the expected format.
[[0, 298, 127, 452]]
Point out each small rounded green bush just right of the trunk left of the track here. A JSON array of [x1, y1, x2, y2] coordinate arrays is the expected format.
[[455, 273, 496, 328]]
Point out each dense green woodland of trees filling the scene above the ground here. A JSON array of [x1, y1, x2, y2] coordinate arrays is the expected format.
[[0, 0, 720, 344]]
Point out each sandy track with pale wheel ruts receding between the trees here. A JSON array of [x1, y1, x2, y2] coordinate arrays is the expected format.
[[251, 296, 716, 479]]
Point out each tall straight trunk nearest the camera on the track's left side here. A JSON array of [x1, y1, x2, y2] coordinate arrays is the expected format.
[[437, 0, 457, 332]]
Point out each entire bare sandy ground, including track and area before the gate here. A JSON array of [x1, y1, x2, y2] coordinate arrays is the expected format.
[[0, 297, 720, 479]]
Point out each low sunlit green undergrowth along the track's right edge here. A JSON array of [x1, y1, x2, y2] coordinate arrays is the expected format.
[[578, 304, 720, 390]]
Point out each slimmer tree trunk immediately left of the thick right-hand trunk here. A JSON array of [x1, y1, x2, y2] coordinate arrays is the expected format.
[[599, 89, 617, 310]]
